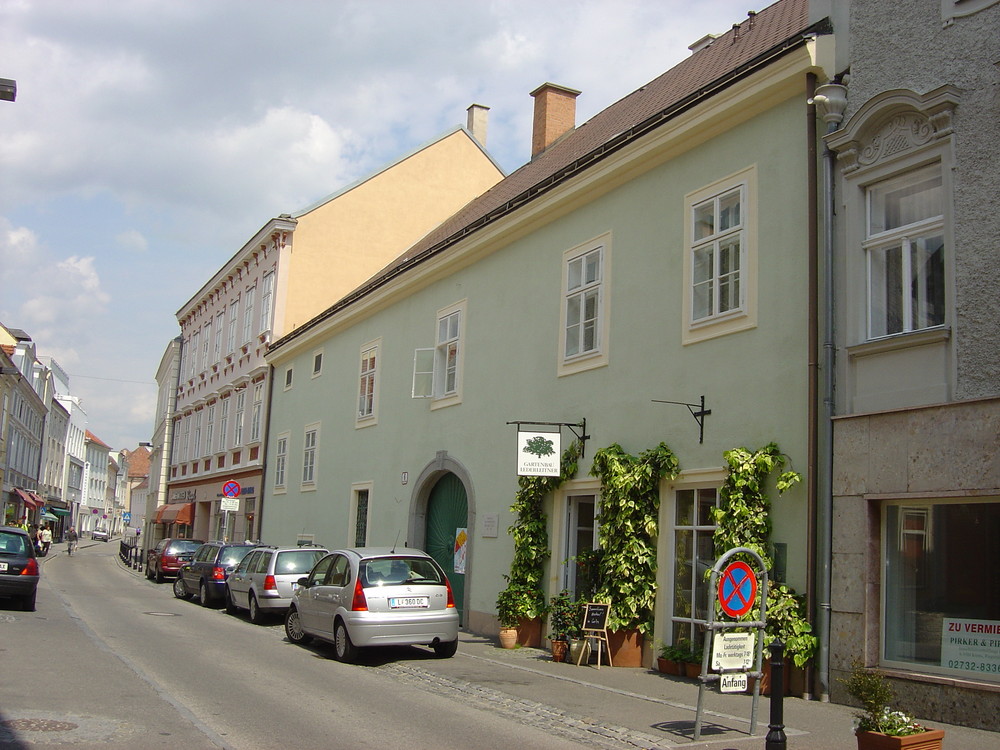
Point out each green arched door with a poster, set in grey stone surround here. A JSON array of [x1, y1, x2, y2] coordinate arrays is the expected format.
[[426, 474, 469, 617]]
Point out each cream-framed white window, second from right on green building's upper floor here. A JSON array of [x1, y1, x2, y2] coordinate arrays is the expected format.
[[556, 232, 611, 377]]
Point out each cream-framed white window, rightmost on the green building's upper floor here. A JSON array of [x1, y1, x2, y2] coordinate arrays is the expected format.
[[681, 165, 759, 344]]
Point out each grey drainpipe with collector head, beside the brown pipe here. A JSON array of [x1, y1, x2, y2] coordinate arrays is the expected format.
[[810, 77, 847, 702]]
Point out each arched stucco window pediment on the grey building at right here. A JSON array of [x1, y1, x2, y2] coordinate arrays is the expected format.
[[826, 86, 959, 176]]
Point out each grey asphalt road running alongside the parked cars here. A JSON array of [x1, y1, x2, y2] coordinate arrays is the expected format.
[[0, 541, 579, 750]]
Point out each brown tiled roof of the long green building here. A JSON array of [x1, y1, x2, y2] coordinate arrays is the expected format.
[[274, 0, 829, 346]]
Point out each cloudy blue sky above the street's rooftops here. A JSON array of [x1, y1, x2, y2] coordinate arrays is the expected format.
[[0, 0, 756, 449]]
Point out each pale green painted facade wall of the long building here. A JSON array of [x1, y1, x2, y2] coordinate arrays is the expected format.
[[263, 96, 808, 636]]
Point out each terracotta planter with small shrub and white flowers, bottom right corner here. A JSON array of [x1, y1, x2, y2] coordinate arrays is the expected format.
[[841, 662, 944, 750]]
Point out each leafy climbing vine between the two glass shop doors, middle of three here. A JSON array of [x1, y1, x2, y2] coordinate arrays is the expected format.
[[590, 443, 679, 634]]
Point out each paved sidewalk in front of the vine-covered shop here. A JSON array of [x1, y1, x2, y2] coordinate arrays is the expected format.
[[436, 633, 1000, 750]]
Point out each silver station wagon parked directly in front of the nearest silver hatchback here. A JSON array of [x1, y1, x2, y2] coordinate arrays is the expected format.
[[226, 546, 330, 625]]
